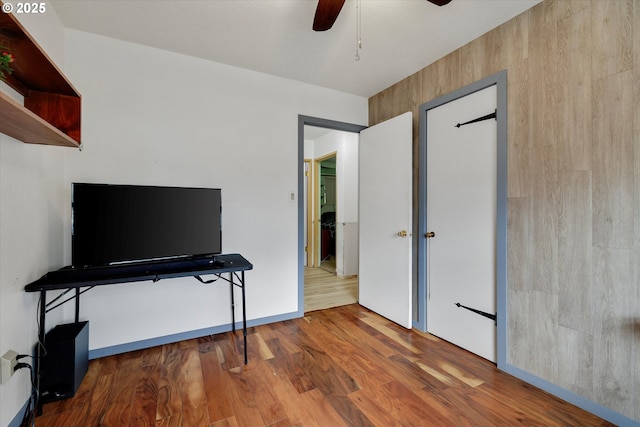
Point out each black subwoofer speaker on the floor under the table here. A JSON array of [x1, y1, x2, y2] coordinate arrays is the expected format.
[[40, 322, 89, 403]]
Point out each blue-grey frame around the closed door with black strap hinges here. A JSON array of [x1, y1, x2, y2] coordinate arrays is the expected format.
[[414, 70, 508, 368]]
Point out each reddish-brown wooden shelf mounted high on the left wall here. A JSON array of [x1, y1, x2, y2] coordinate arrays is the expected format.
[[0, 1, 81, 147]]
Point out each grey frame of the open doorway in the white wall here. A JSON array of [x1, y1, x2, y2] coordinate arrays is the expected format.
[[298, 114, 367, 317]]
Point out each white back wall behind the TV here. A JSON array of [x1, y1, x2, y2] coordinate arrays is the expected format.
[[61, 31, 368, 349]]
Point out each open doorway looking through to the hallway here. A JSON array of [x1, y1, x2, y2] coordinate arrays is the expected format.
[[299, 116, 364, 315]]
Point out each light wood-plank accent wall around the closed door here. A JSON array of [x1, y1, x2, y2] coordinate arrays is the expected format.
[[369, 0, 640, 421]]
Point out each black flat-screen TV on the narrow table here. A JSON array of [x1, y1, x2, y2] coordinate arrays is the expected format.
[[71, 183, 222, 268]]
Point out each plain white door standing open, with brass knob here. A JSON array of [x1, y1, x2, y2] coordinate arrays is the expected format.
[[358, 112, 413, 328]]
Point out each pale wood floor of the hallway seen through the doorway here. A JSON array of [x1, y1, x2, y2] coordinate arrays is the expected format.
[[304, 267, 358, 313]]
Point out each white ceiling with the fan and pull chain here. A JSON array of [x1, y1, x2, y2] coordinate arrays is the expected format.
[[50, 0, 541, 97]]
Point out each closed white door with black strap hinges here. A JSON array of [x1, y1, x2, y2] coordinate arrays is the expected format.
[[427, 85, 497, 362]]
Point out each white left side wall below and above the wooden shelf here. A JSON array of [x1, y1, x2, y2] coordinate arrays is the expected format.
[[0, 4, 68, 426]]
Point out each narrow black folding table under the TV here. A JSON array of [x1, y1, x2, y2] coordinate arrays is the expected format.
[[24, 254, 253, 410]]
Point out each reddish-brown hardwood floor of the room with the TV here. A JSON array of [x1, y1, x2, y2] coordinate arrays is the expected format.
[[36, 304, 612, 427]]
